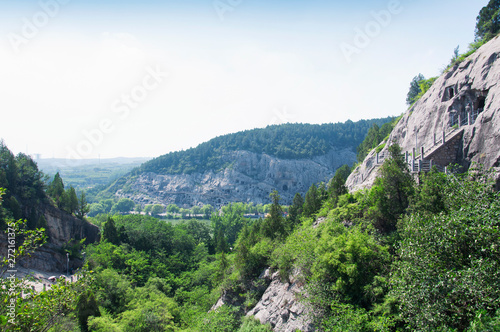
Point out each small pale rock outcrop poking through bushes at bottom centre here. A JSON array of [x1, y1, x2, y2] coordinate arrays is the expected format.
[[247, 272, 314, 332]]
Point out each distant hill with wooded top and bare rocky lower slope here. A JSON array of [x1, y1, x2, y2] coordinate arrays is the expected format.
[[103, 118, 392, 207]]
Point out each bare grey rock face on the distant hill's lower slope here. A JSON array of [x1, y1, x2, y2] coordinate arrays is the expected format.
[[116, 149, 356, 207]]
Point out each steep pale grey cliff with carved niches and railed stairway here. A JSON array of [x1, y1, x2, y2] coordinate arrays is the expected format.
[[347, 37, 500, 191]]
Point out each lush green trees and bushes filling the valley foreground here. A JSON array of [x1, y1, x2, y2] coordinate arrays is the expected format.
[[0, 139, 500, 331]]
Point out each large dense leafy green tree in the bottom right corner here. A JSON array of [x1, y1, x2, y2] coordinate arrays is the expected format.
[[390, 170, 500, 331]]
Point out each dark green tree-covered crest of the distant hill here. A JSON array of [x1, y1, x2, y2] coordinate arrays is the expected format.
[[133, 117, 392, 174]]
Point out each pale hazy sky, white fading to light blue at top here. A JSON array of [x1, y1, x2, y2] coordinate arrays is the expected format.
[[0, 0, 488, 159]]
